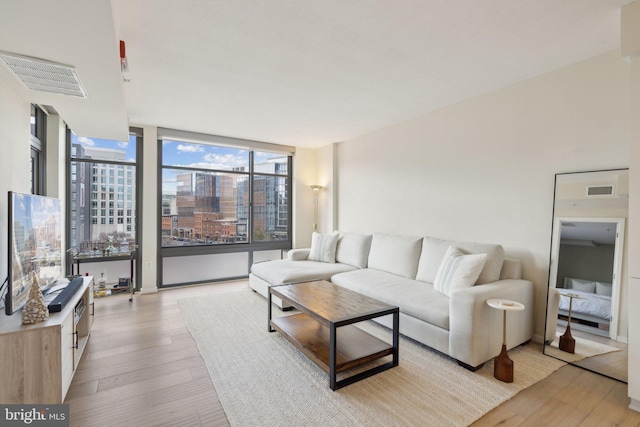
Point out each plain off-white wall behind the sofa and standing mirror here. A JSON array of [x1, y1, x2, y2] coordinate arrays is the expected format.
[[336, 52, 630, 338]]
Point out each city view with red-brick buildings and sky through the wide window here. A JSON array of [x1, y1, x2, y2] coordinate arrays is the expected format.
[[162, 140, 290, 247]]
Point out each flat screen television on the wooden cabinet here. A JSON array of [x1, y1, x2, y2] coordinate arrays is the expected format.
[[5, 191, 64, 315]]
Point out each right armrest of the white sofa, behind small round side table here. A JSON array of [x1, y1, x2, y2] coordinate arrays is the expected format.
[[449, 279, 534, 367]]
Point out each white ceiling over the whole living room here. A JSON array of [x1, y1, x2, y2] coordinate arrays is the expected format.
[[0, 0, 629, 147]]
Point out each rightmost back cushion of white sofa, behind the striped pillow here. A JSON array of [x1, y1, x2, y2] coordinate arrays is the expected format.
[[416, 237, 504, 285]]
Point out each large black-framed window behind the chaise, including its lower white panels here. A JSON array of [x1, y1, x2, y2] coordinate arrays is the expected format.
[[159, 131, 293, 286]]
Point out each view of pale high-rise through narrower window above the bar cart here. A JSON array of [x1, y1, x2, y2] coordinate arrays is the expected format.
[[69, 133, 136, 256]]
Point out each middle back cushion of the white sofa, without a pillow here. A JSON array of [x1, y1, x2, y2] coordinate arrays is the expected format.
[[368, 233, 422, 279]]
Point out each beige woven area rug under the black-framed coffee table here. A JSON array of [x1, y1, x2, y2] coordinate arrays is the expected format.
[[179, 291, 564, 426]]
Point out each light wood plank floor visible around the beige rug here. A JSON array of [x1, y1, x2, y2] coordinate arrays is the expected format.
[[65, 281, 640, 427]]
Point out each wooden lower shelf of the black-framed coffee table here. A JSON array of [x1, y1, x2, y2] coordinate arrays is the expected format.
[[270, 313, 398, 390]]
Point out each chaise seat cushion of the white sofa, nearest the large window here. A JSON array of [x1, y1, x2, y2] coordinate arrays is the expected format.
[[251, 259, 355, 285]]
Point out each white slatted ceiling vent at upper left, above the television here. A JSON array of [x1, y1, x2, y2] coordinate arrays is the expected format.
[[0, 52, 87, 98]]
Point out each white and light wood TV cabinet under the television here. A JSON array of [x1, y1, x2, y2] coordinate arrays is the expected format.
[[0, 276, 94, 404]]
